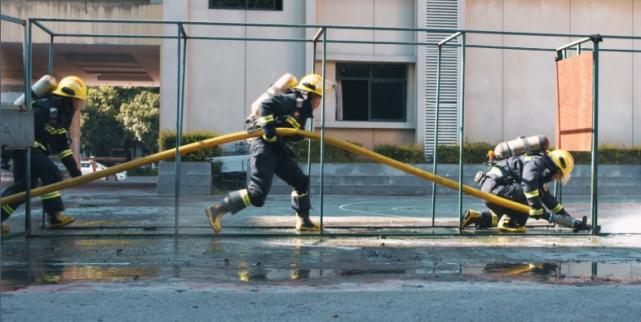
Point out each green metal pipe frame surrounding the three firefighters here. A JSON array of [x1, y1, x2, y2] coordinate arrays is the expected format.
[[0, 15, 641, 236]]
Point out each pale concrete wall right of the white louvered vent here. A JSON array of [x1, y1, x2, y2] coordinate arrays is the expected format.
[[461, 0, 641, 146]]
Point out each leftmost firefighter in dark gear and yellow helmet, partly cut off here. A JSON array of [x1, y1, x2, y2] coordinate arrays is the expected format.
[[2, 76, 87, 233]]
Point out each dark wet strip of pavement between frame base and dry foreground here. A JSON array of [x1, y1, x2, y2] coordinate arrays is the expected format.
[[0, 236, 641, 291]]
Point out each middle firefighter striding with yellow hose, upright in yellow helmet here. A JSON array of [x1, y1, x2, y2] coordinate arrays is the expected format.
[[205, 74, 323, 233]]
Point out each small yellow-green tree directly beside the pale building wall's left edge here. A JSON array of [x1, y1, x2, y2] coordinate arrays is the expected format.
[[118, 90, 160, 153]]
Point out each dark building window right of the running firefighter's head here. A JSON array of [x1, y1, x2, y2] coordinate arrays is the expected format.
[[336, 63, 407, 122]]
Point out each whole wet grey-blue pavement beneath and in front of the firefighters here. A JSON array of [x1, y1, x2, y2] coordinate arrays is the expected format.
[[0, 183, 641, 321]]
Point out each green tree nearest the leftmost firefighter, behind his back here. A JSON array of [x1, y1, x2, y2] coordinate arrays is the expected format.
[[80, 86, 126, 156]]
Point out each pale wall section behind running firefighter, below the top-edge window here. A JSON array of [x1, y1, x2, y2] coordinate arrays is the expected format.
[[160, 0, 306, 133]]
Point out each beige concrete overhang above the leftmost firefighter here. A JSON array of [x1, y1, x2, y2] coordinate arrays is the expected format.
[[0, 0, 163, 87]]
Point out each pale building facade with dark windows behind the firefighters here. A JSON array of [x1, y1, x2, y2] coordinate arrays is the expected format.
[[2, 0, 641, 150]]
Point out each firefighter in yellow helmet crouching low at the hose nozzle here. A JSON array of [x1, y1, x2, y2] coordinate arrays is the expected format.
[[462, 149, 591, 233]]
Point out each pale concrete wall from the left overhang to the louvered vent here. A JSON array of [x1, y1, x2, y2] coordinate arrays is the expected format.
[[160, 0, 416, 146]]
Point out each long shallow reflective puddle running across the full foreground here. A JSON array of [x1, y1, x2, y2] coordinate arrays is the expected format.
[[0, 261, 641, 291]]
